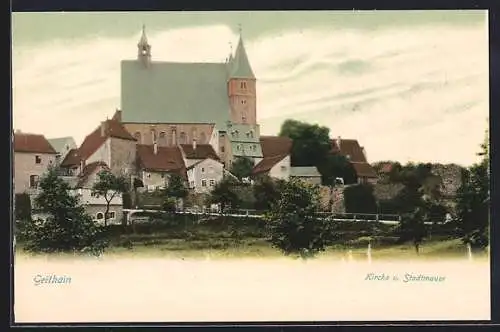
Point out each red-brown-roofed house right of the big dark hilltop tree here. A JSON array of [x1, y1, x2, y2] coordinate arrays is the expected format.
[[331, 137, 378, 183]]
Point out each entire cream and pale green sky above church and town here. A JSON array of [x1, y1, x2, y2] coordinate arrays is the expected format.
[[12, 10, 489, 166]]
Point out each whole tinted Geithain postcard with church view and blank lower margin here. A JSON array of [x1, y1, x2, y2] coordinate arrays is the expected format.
[[12, 11, 491, 323]]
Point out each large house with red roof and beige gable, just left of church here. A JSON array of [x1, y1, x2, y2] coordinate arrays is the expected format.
[[60, 119, 136, 175]]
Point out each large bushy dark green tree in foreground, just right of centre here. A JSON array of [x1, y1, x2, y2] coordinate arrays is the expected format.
[[265, 180, 330, 258]]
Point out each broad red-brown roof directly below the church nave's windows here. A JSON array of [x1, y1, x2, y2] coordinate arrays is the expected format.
[[137, 144, 186, 177]]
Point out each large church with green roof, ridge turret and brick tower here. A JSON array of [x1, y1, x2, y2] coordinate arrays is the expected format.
[[114, 26, 263, 168]]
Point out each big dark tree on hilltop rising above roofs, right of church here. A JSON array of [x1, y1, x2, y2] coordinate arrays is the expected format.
[[279, 120, 357, 185]]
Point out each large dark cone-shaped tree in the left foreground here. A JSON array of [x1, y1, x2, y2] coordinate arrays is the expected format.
[[23, 168, 107, 253]]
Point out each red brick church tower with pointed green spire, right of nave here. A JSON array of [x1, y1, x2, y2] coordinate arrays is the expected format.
[[228, 31, 257, 125]]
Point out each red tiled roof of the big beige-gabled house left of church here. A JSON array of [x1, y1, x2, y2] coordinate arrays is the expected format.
[[78, 120, 136, 160]]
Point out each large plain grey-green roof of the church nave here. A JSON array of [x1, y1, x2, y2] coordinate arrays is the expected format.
[[121, 60, 230, 128]]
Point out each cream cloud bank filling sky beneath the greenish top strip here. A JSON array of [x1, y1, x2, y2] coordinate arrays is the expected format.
[[13, 21, 488, 164]]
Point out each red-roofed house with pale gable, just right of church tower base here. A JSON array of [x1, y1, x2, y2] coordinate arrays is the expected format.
[[252, 136, 292, 180]]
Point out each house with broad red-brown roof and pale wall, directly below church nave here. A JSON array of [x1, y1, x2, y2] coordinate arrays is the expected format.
[[136, 144, 187, 191]]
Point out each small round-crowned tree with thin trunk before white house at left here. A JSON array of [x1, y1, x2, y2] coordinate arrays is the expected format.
[[92, 169, 128, 226]]
